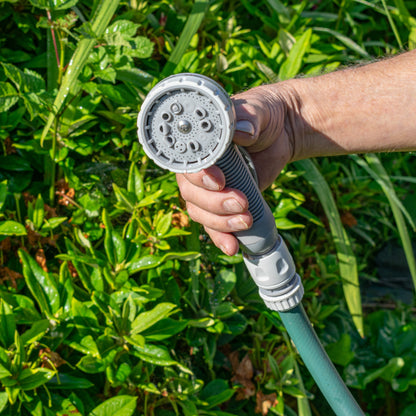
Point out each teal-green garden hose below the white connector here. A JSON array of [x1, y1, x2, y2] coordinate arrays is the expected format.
[[279, 304, 364, 416]]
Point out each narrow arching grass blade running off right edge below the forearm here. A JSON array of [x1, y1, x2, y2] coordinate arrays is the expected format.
[[352, 153, 416, 290]]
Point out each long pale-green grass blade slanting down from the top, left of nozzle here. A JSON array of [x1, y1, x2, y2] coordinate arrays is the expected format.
[[41, 0, 119, 145]]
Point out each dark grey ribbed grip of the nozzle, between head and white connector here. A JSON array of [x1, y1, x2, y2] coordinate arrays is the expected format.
[[216, 145, 279, 255]]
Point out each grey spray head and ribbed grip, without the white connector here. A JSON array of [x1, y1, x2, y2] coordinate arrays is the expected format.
[[138, 74, 278, 255]]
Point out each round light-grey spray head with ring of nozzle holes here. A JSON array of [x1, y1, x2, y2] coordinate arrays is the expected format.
[[137, 74, 235, 173]]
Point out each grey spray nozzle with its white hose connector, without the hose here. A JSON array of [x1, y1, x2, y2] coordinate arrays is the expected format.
[[137, 73, 303, 311]]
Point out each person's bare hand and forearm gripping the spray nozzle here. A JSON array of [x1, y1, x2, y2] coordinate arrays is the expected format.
[[177, 50, 416, 255]]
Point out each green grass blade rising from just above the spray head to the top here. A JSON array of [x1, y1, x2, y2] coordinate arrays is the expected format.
[[162, 0, 209, 77]]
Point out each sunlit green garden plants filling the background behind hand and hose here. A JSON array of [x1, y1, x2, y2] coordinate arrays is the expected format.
[[0, 0, 416, 416]]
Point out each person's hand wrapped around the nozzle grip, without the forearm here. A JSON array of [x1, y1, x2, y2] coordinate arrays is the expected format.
[[177, 86, 293, 255]]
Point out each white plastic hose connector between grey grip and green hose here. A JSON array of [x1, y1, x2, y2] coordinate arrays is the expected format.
[[244, 235, 304, 312]]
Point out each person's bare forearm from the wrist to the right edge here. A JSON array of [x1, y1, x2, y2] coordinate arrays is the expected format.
[[280, 51, 416, 160]]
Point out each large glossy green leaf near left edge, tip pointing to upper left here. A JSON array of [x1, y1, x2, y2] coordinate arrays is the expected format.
[[19, 249, 60, 319]]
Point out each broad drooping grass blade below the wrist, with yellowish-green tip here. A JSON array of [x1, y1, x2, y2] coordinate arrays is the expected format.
[[295, 159, 364, 336]]
